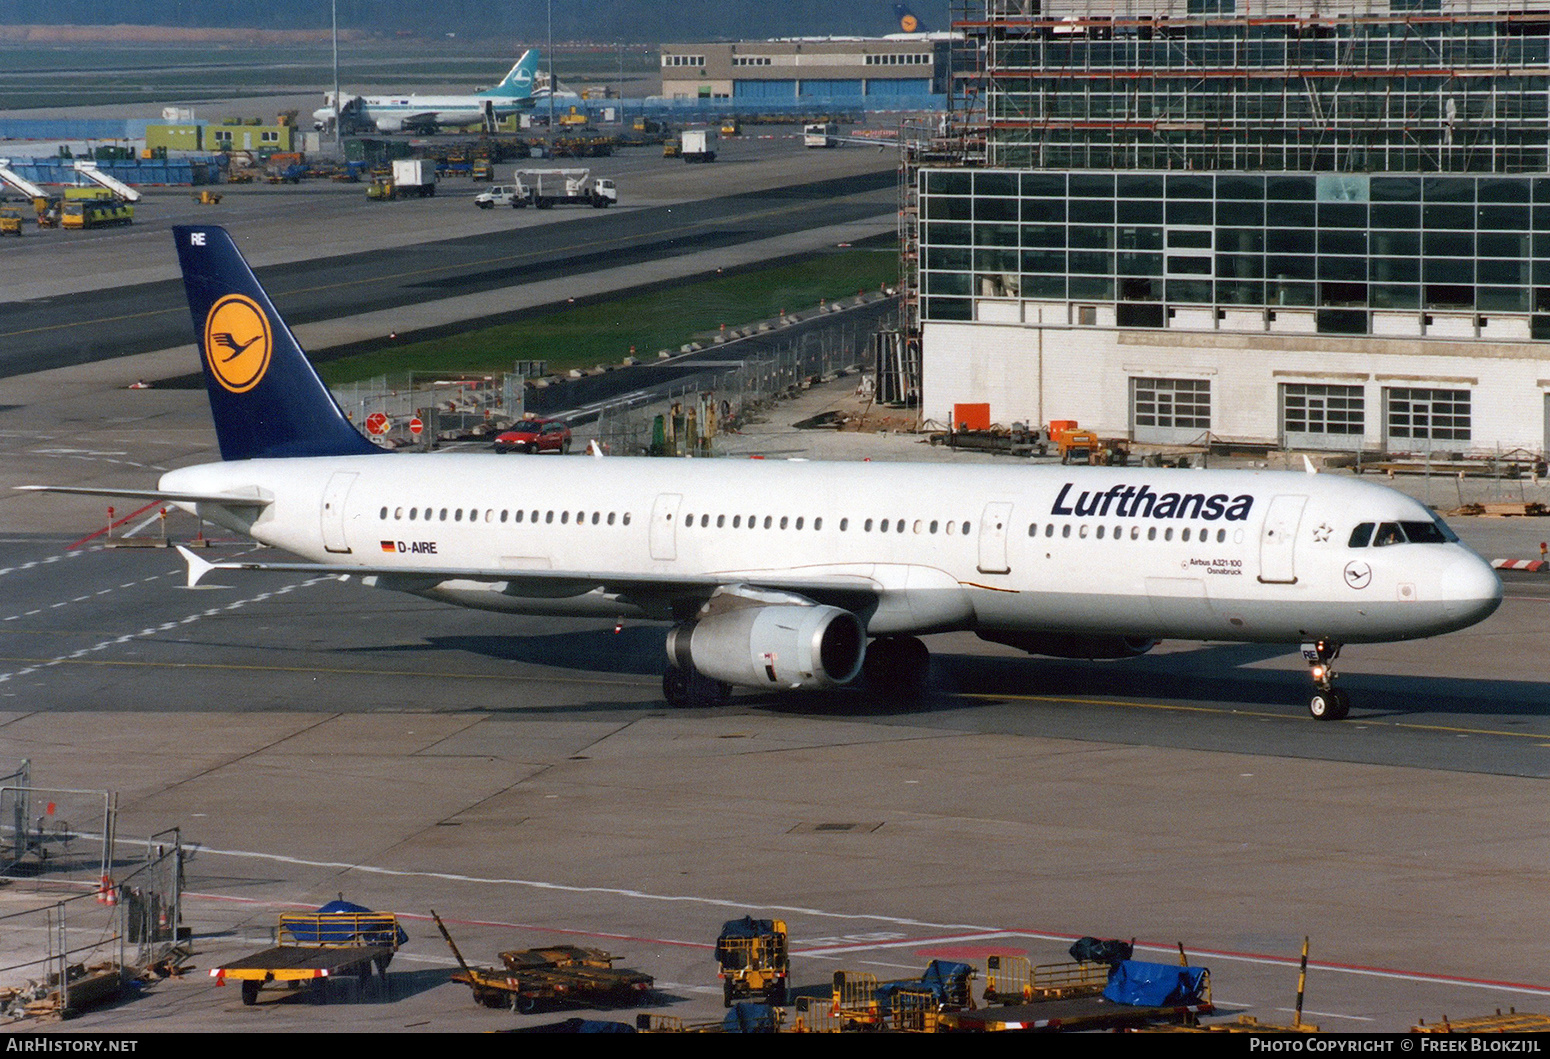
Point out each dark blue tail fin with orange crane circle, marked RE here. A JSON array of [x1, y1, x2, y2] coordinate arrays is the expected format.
[[172, 225, 383, 459]]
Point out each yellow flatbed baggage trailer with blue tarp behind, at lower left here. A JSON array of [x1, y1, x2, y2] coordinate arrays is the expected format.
[[209, 901, 408, 1005]]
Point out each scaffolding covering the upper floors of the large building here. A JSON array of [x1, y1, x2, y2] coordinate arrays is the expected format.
[[953, 0, 1550, 174]]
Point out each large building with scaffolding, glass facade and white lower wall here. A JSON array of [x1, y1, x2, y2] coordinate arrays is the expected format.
[[905, 0, 1550, 454]]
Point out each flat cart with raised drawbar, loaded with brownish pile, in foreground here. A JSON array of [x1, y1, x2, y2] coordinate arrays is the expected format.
[[431, 910, 656, 1012]]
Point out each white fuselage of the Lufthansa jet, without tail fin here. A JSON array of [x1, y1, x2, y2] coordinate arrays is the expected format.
[[161, 454, 1500, 643]]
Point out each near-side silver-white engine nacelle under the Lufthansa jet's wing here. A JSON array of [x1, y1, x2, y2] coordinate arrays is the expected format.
[[668, 606, 866, 688]]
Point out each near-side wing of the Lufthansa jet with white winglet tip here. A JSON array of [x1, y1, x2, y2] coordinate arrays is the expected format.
[[178, 547, 882, 611]]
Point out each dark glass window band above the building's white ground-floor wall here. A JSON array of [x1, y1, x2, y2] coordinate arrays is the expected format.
[[919, 169, 1550, 336]]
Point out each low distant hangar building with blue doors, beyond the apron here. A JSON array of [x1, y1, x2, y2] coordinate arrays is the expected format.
[[662, 34, 949, 103]]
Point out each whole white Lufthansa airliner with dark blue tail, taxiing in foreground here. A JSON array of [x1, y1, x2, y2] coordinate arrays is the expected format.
[[29, 226, 1502, 719]]
